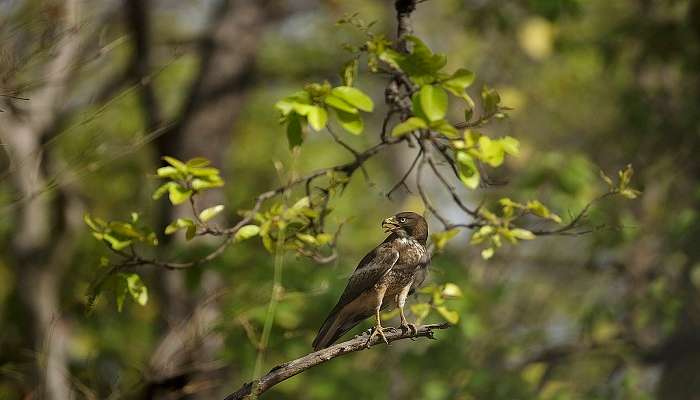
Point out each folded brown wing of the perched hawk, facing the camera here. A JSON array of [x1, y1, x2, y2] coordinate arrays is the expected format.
[[333, 243, 399, 311]]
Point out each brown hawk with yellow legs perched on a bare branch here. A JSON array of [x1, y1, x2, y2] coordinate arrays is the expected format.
[[313, 212, 429, 350]]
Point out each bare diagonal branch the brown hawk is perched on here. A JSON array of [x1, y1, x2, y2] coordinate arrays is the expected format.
[[225, 323, 450, 400]]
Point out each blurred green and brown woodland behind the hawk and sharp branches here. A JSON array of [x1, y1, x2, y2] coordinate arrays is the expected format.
[[0, 0, 700, 400]]
